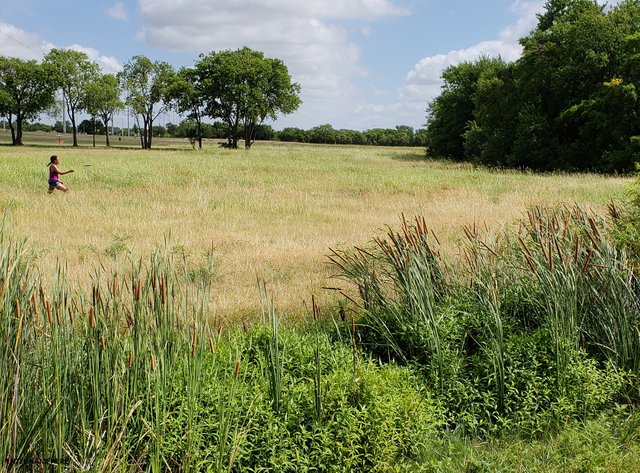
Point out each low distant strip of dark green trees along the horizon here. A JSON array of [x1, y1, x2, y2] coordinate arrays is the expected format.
[[6, 120, 426, 146]]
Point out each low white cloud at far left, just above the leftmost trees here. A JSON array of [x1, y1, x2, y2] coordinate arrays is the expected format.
[[0, 23, 122, 73]]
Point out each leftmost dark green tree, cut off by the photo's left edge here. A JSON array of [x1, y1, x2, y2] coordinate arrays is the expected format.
[[0, 56, 57, 146]]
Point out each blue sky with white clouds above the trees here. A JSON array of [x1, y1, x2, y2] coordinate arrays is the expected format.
[[0, 0, 617, 130]]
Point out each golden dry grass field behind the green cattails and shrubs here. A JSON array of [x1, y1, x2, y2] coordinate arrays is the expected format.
[[0, 134, 628, 317]]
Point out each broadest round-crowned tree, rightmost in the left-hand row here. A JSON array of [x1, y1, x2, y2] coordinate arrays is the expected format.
[[196, 47, 301, 148]]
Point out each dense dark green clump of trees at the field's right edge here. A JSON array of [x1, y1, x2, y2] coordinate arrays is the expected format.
[[426, 0, 640, 172]]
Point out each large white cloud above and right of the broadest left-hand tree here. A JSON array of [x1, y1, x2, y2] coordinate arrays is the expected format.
[[138, 0, 408, 127]]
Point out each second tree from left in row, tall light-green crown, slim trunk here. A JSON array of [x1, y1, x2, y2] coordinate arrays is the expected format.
[[44, 48, 99, 146]]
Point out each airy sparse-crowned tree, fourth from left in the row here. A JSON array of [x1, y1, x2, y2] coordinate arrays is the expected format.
[[118, 56, 175, 149]]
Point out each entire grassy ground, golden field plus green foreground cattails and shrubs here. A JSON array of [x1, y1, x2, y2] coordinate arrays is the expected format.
[[0, 134, 640, 472]]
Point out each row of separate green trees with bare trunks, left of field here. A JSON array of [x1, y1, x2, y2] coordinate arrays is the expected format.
[[0, 47, 301, 149]]
